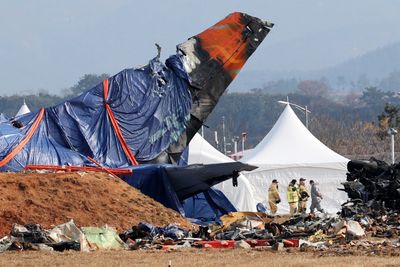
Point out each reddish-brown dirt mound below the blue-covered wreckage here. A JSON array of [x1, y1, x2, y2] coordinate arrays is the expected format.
[[0, 172, 190, 237]]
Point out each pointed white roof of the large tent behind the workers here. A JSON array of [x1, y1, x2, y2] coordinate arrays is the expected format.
[[242, 105, 349, 166]]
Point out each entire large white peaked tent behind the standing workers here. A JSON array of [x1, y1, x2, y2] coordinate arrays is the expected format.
[[242, 105, 349, 213]]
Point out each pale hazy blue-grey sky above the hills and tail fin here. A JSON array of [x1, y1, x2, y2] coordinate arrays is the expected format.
[[0, 0, 400, 95]]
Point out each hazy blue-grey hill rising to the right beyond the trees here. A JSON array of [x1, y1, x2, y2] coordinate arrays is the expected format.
[[230, 42, 400, 93]]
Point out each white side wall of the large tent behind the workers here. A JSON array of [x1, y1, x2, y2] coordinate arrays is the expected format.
[[244, 166, 347, 214]]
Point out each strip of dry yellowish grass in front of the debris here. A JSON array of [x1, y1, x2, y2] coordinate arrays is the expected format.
[[0, 249, 400, 267]]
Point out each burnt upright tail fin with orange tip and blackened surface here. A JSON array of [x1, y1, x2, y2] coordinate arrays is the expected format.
[[142, 12, 273, 163]]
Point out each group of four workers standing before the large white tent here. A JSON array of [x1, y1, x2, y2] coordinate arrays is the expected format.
[[268, 178, 324, 216]]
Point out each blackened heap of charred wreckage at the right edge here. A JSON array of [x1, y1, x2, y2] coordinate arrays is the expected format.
[[341, 158, 400, 238]]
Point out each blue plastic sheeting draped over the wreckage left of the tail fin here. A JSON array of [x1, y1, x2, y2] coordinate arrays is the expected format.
[[0, 55, 192, 171]]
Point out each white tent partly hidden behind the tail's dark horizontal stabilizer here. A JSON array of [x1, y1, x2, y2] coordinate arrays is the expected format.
[[188, 134, 256, 211]]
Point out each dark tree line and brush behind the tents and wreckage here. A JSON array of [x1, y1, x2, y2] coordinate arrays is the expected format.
[[0, 74, 400, 161]]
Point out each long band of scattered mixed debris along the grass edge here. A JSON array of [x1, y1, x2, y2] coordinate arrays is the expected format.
[[0, 212, 400, 255]]
